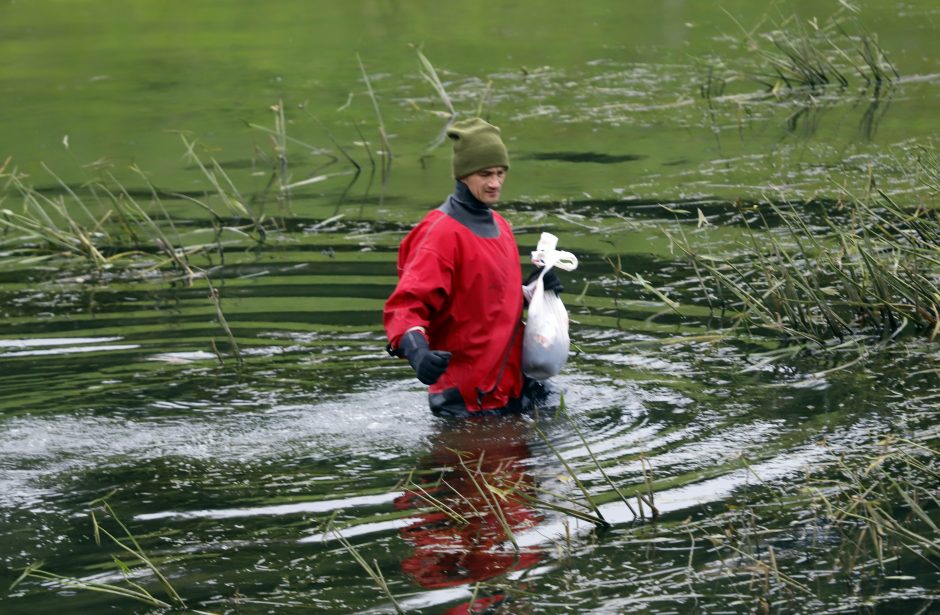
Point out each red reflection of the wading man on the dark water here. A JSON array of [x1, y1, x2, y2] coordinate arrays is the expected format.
[[395, 417, 541, 613]]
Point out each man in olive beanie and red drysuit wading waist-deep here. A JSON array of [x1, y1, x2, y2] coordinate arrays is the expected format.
[[383, 118, 561, 416]]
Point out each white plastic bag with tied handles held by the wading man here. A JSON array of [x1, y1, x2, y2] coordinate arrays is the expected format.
[[522, 233, 578, 380]]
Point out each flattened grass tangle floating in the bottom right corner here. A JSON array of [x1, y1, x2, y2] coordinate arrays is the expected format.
[[668, 437, 940, 612]]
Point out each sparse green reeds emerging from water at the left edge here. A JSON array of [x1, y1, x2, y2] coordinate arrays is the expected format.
[[0, 103, 374, 366]]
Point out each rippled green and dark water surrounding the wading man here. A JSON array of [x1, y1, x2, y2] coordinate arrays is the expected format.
[[0, 0, 940, 613]]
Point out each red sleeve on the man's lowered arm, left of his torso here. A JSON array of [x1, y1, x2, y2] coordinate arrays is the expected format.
[[382, 242, 454, 349]]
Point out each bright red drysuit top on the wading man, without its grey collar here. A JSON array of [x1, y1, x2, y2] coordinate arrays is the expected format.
[[384, 209, 522, 412]]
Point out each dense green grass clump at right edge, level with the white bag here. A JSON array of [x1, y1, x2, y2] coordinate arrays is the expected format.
[[667, 176, 940, 345]]
